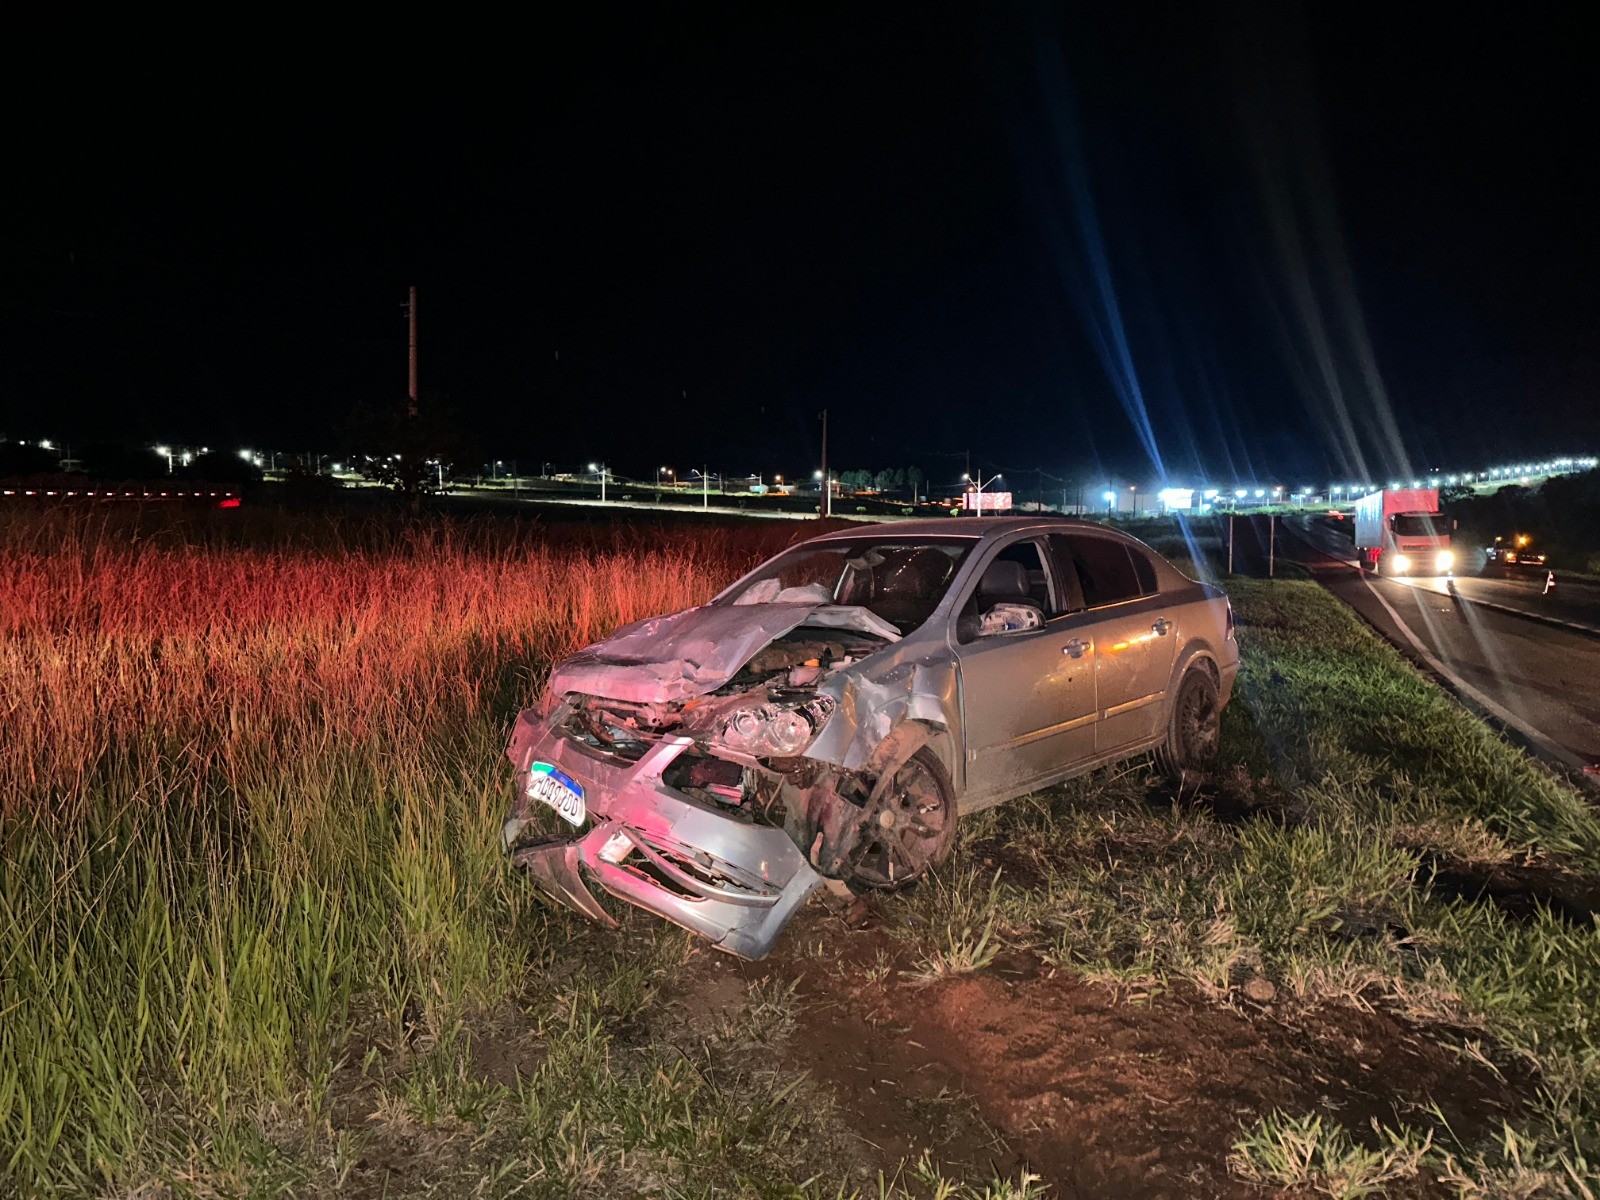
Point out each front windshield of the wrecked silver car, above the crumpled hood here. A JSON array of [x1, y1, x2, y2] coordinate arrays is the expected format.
[[725, 538, 978, 634]]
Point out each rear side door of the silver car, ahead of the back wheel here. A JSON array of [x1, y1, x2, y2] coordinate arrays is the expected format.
[[1050, 530, 1178, 754]]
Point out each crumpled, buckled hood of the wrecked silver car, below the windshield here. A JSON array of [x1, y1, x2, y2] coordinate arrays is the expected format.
[[550, 603, 899, 704]]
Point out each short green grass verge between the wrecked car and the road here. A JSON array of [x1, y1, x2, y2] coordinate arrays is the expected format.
[[909, 579, 1600, 1197]]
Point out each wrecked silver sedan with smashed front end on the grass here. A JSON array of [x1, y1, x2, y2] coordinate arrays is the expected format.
[[504, 517, 1238, 958]]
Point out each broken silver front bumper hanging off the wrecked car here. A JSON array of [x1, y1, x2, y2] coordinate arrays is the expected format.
[[504, 710, 822, 958]]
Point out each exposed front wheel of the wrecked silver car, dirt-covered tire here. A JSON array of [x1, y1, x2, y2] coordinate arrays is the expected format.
[[843, 746, 955, 891]]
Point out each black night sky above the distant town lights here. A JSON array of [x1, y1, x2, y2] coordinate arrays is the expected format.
[[0, 3, 1600, 482]]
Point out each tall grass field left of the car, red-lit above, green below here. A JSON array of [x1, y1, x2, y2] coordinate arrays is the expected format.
[[0, 514, 800, 1194]]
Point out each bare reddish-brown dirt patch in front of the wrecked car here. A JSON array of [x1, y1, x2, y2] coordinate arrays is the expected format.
[[682, 906, 1526, 1200]]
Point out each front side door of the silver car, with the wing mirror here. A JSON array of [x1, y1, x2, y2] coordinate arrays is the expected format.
[[950, 538, 1094, 803]]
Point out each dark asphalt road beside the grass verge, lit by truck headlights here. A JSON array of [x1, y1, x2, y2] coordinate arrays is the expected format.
[[1278, 518, 1600, 784]]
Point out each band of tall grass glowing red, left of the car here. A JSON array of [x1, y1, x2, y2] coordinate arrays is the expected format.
[[0, 518, 800, 816]]
